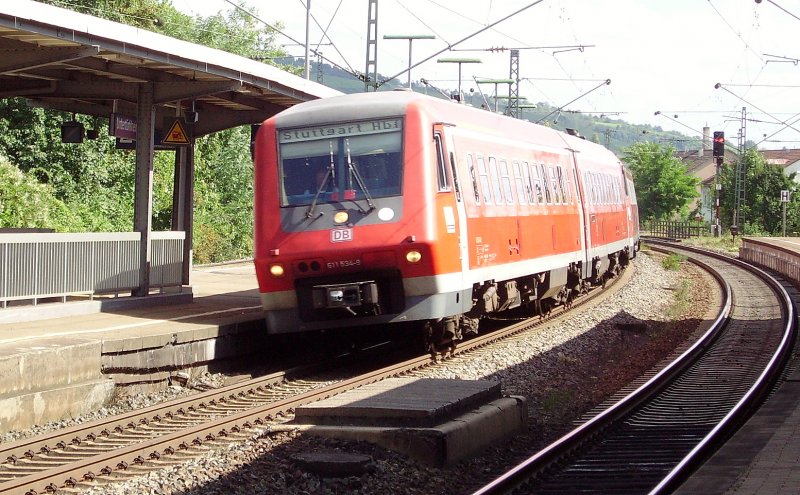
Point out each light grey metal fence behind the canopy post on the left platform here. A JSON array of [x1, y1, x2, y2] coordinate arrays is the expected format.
[[0, 232, 186, 307]]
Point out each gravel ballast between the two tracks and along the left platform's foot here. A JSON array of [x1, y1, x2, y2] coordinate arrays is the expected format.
[[6, 251, 711, 495]]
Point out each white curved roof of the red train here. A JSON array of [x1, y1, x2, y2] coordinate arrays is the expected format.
[[273, 90, 619, 162]]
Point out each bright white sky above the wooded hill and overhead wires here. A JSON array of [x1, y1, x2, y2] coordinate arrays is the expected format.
[[171, 0, 800, 149]]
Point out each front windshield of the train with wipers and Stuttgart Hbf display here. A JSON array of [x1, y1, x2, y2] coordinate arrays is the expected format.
[[278, 117, 403, 206]]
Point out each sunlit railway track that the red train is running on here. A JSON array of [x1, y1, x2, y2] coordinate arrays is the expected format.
[[0, 260, 631, 495]]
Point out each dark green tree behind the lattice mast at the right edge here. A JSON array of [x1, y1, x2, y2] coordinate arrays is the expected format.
[[720, 148, 800, 235]]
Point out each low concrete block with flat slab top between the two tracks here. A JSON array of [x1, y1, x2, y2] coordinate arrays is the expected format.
[[289, 378, 528, 466]]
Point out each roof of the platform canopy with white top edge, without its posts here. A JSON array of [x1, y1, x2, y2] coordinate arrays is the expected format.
[[0, 0, 341, 137]]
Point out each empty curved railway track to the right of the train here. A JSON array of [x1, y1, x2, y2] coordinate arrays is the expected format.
[[474, 242, 796, 495]]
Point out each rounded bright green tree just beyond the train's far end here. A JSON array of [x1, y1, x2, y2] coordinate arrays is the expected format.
[[622, 143, 700, 220]]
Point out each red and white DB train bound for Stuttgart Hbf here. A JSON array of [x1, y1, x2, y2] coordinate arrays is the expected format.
[[254, 91, 639, 350]]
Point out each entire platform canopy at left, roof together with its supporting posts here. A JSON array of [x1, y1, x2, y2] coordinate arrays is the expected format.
[[0, 0, 341, 296]]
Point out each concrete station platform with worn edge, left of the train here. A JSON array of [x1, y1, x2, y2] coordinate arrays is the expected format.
[[0, 262, 266, 431]]
